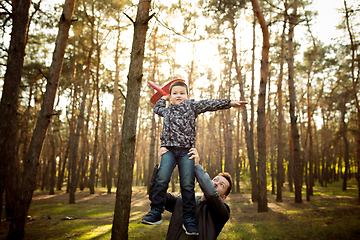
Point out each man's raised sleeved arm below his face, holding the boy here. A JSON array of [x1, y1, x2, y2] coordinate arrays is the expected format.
[[195, 165, 230, 219]]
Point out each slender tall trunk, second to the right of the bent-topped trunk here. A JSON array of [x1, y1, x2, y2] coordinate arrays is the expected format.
[[288, 0, 303, 203]]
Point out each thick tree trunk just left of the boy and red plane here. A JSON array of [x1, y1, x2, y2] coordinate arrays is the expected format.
[[111, 0, 152, 237]]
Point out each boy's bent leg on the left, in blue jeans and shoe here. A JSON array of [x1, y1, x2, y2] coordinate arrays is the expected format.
[[141, 151, 176, 225]]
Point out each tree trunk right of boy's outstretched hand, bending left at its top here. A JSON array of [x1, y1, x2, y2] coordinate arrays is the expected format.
[[251, 0, 270, 212]]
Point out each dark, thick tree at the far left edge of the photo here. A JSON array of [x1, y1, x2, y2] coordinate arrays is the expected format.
[[0, 0, 31, 219]]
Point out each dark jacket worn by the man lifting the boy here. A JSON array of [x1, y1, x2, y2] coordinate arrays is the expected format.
[[149, 165, 230, 240]]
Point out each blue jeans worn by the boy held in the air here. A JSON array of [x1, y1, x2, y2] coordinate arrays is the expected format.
[[150, 147, 196, 219]]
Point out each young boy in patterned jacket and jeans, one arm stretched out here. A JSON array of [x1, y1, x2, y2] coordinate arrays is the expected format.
[[141, 81, 247, 235]]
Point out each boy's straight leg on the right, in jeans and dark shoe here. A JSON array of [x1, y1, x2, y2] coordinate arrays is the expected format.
[[178, 149, 199, 235]]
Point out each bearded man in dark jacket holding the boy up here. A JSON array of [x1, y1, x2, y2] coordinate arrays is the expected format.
[[149, 148, 232, 240]]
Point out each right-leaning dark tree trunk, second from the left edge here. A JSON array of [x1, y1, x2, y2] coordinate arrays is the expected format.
[[7, 0, 75, 237]]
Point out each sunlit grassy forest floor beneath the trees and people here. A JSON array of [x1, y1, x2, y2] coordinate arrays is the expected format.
[[0, 180, 360, 240]]
